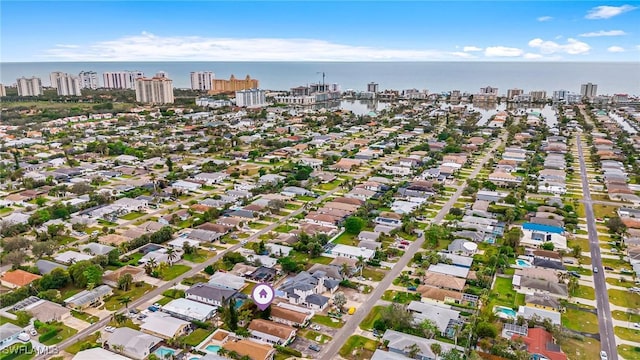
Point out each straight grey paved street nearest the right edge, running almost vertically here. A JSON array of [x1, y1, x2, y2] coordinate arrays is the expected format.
[[576, 131, 618, 360]]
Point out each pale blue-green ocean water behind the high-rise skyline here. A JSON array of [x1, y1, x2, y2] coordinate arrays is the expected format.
[[0, 62, 640, 96]]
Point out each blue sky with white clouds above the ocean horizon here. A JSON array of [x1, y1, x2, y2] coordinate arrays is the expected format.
[[0, 0, 640, 62]]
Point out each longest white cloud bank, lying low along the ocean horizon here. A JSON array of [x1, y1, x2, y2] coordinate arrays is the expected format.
[[42, 32, 473, 61]]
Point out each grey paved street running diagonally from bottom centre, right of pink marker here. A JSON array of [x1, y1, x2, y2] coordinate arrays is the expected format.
[[319, 136, 505, 360]]
